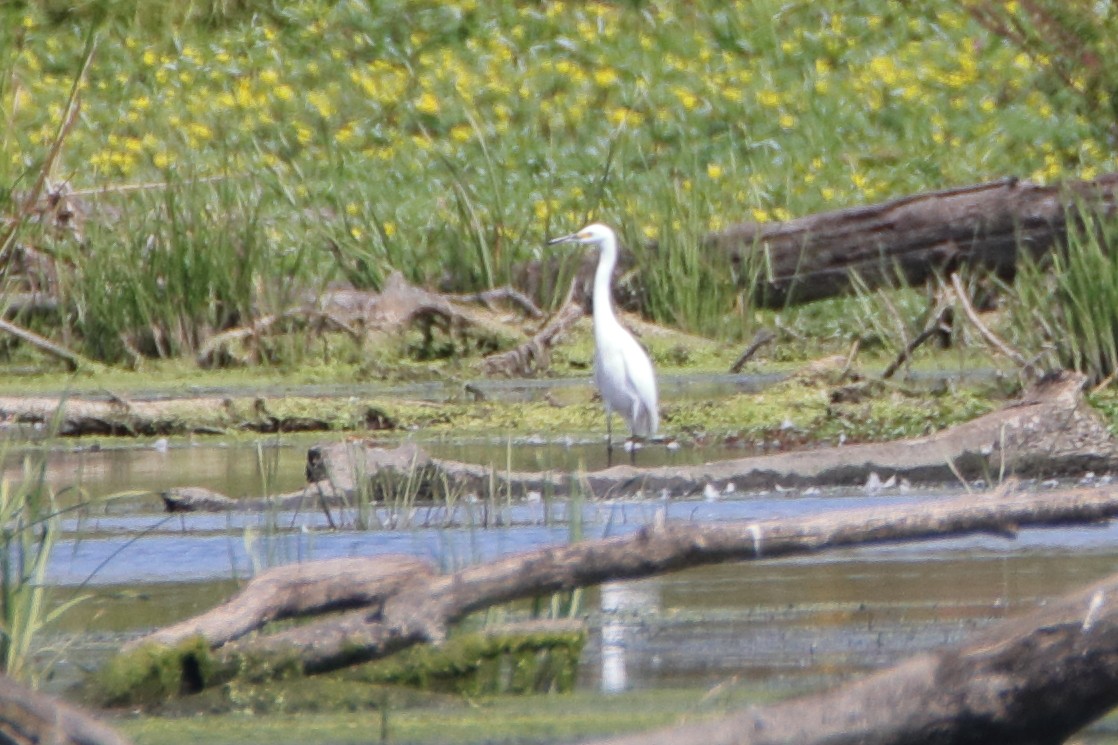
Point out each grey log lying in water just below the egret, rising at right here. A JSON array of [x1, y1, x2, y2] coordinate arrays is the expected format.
[[306, 373, 1118, 499]]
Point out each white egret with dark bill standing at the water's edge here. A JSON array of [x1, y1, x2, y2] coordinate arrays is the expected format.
[[548, 223, 660, 462]]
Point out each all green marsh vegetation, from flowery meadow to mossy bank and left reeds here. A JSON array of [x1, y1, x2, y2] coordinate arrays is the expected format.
[[0, 0, 1118, 738]]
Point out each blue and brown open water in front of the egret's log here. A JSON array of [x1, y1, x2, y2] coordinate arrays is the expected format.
[[48, 490, 1118, 690]]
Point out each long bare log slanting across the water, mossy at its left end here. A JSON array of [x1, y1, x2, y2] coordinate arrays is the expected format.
[[111, 478, 1118, 690]]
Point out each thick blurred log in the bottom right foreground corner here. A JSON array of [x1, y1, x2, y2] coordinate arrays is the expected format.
[[594, 563, 1118, 745]]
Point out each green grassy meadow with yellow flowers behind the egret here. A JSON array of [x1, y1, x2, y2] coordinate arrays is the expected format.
[[0, 0, 1118, 364]]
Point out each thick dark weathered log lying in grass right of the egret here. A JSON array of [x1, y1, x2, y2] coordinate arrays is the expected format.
[[688, 173, 1118, 308]]
